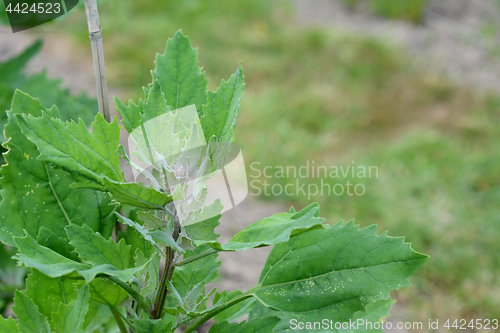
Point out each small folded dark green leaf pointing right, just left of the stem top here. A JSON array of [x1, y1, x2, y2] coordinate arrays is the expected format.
[[104, 179, 172, 210]]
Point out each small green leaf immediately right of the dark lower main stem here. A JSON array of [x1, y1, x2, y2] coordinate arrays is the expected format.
[[172, 245, 221, 298]]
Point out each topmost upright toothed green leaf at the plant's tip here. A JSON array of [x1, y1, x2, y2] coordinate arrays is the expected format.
[[153, 30, 208, 117]]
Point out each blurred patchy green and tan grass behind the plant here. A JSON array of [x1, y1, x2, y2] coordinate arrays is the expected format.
[[0, 0, 500, 328]]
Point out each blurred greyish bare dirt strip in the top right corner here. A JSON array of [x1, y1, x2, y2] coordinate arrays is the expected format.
[[293, 0, 500, 91]]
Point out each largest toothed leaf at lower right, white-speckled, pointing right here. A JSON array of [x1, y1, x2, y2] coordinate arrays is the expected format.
[[252, 222, 427, 322]]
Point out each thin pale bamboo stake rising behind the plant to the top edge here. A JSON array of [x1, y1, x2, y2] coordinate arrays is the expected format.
[[84, 0, 111, 122]]
